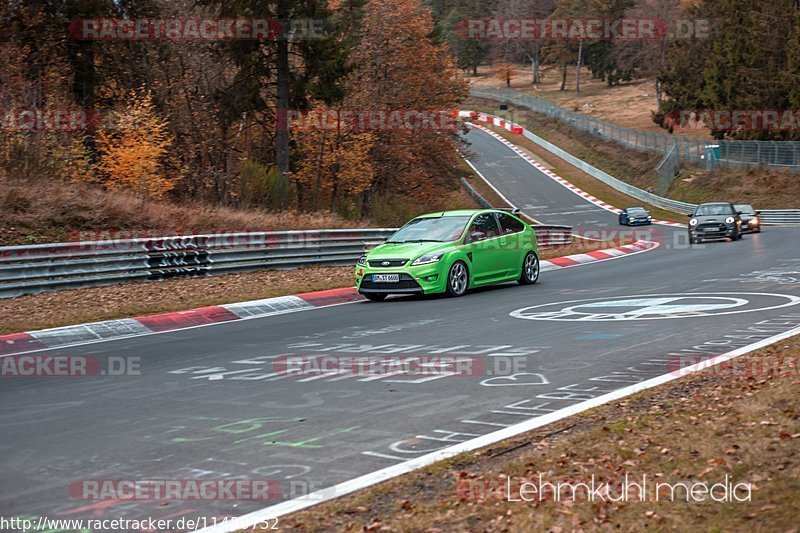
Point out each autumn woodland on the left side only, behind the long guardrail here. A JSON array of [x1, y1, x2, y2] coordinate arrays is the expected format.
[[0, 0, 467, 231]]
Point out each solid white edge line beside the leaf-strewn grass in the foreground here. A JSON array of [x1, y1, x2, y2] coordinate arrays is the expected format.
[[199, 327, 800, 533]]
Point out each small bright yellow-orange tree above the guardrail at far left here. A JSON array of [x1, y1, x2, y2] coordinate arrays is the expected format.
[[97, 91, 175, 198]]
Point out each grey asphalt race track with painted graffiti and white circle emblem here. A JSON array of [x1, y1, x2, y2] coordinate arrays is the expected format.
[[0, 125, 800, 528]]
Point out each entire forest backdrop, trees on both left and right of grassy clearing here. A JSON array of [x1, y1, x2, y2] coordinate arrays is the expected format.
[[0, 0, 800, 243]]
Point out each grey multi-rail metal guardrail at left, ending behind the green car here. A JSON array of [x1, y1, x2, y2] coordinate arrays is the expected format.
[[0, 226, 572, 298]]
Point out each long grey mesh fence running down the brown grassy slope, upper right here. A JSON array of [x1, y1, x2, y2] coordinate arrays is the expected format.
[[470, 87, 800, 172]]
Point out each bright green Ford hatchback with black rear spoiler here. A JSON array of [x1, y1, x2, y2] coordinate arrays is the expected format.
[[356, 209, 539, 301]]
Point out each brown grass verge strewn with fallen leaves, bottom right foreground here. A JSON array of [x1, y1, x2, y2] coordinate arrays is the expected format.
[[272, 337, 800, 532]]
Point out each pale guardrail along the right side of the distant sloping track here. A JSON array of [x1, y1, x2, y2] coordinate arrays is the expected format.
[[460, 111, 800, 225]]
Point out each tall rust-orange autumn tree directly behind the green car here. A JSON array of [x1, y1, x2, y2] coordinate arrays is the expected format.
[[343, 0, 467, 214]]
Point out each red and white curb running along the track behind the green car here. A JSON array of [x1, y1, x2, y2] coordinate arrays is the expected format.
[[0, 241, 659, 357]]
